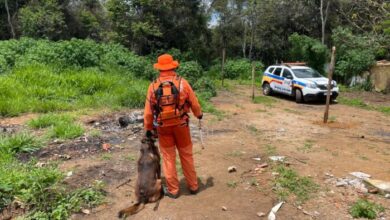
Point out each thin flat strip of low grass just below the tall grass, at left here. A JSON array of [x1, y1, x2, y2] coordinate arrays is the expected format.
[[27, 113, 74, 128]]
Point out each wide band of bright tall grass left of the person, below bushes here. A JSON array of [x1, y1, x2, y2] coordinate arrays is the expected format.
[[0, 65, 148, 116]]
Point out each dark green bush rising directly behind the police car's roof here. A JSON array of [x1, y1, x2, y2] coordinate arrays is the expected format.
[[288, 33, 329, 73]]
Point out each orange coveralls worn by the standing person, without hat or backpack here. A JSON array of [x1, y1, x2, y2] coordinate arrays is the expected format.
[[144, 70, 202, 195]]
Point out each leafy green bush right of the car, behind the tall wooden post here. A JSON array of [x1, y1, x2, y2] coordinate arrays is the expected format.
[[332, 27, 380, 82]]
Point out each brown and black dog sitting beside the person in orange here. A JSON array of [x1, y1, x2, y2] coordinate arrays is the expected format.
[[118, 137, 164, 218]]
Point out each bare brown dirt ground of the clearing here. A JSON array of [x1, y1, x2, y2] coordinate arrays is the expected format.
[[3, 86, 390, 220]]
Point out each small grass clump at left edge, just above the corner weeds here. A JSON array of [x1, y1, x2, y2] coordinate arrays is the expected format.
[[0, 133, 42, 154]]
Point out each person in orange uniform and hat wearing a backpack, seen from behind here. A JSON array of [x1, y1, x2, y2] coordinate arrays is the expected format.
[[144, 54, 203, 198]]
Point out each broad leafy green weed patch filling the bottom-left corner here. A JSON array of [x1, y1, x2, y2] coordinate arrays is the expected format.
[[0, 142, 104, 217]]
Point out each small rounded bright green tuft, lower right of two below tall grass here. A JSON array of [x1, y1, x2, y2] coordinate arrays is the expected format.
[[49, 123, 84, 139]]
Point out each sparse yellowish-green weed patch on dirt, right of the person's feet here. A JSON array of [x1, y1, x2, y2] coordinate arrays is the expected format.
[[275, 166, 319, 202]]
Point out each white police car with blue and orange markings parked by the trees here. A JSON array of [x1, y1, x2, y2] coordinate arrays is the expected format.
[[262, 64, 339, 103]]
